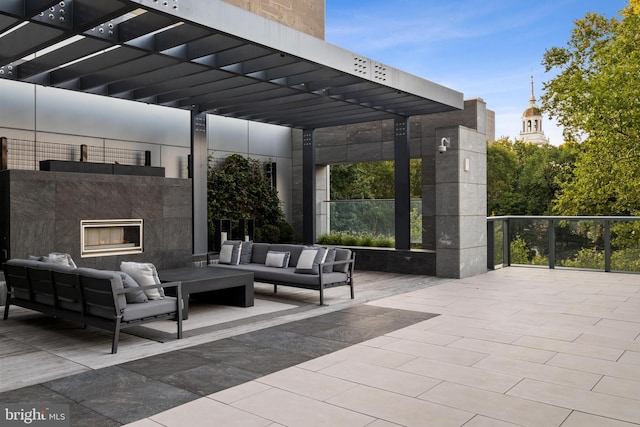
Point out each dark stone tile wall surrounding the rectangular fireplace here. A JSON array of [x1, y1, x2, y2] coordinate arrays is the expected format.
[[0, 170, 193, 269]]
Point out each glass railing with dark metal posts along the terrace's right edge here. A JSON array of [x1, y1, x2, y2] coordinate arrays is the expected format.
[[487, 216, 640, 272]]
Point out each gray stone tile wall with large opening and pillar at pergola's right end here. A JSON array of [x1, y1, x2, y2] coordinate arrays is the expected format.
[[292, 99, 495, 278]]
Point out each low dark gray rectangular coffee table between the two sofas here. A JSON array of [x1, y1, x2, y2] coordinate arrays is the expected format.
[[158, 267, 253, 319]]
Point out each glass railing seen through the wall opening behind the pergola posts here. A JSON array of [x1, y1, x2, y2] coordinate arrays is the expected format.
[[325, 199, 422, 245]]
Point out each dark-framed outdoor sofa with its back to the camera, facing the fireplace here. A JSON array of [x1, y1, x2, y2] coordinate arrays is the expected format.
[[3, 259, 182, 354]]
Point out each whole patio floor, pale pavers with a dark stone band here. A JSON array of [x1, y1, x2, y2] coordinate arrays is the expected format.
[[0, 267, 640, 427]]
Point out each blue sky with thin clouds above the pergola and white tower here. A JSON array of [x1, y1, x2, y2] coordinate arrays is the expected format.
[[326, 0, 628, 145]]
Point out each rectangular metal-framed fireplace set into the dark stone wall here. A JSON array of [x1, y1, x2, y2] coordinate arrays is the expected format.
[[80, 219, 143, 258]]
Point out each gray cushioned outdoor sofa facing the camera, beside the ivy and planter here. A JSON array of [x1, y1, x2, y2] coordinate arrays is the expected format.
[[214, 240, 355, 305]]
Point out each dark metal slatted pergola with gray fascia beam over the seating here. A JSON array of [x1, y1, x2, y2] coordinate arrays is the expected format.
[[0, 0, 463, 252]]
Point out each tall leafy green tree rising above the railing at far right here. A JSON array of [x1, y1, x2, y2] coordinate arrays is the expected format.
[[541, 0, 640, 215]]
